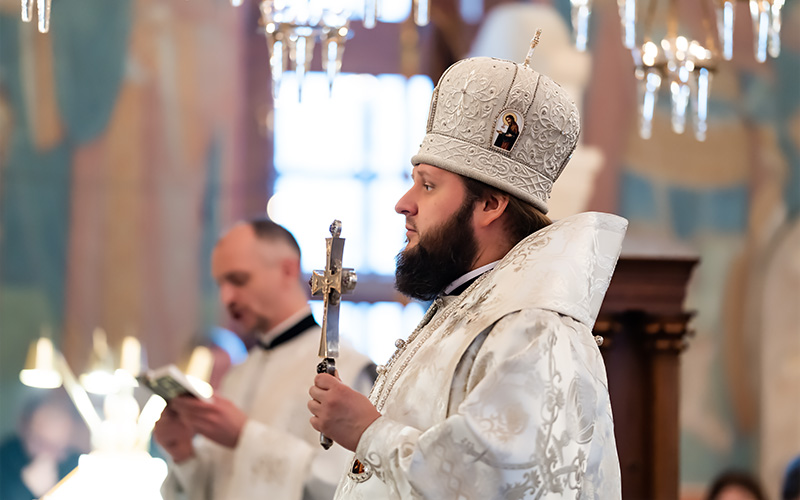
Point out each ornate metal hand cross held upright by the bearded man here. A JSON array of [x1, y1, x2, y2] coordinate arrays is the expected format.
[[309, 220, 357, 450]]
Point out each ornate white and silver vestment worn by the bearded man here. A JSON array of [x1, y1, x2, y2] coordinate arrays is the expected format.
[[336, 213, 627, 500]]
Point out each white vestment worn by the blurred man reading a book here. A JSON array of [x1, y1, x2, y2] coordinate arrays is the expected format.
[[162, 318, 374, 500]]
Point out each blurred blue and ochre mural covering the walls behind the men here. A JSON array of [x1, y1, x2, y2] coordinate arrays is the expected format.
[[0, 0, 800, 497]]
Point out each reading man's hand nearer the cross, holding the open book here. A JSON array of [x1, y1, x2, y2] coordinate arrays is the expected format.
[[170, 396, 247, 448]]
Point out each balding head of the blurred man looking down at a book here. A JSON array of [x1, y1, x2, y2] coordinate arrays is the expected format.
[[211, 219, 307, 333]]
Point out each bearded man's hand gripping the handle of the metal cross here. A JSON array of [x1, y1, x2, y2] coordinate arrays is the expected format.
[[308, 373, 381, 451]]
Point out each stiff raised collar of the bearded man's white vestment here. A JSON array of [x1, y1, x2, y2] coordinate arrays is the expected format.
[[432, 212, 628, 328]]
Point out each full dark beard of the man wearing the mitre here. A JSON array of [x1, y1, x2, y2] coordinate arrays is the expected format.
[[394, 200, 478, 301]]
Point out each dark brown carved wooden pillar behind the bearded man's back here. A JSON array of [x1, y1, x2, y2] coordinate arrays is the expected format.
[[595, 256, 697, 500]]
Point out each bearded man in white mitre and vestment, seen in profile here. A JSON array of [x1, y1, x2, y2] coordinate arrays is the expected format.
[[308, 47, 627, 500]]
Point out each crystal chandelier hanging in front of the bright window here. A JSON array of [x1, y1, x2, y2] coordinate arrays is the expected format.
[[231, 0, 430, 99]]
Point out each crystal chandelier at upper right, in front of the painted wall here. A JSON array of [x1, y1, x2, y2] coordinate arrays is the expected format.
[[570, 0, 785, 141]]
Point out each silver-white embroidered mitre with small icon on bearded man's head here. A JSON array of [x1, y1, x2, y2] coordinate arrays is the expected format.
[[411, 53, 580, 213]]
